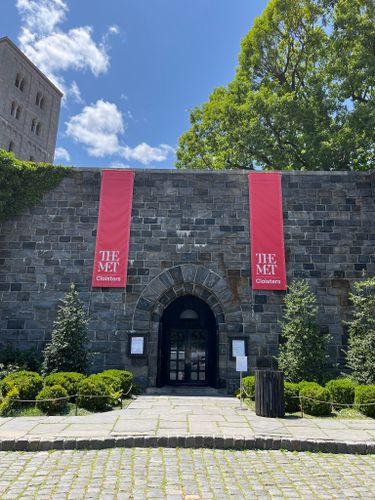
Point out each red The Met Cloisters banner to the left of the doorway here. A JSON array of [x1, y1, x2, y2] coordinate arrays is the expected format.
[[92, 170, 134, 288]]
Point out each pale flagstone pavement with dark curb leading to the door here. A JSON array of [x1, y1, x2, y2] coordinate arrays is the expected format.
[[0, 395, 375, 454]]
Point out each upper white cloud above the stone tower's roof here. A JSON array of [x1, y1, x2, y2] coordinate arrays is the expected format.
[[16, 0, 112, 92]]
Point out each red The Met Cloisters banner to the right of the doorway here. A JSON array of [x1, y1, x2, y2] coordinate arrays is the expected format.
[[249, 172, 286, 290]]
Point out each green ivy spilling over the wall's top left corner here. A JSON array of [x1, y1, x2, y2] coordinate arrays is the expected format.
[[0, 149, 70, 220]]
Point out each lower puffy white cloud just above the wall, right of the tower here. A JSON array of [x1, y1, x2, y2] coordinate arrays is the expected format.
[[66, 99, 174, 165]]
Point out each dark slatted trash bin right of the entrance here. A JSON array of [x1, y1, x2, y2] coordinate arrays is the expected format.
[[255, 370, 285, 418]]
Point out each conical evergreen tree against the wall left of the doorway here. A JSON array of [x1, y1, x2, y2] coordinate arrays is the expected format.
[[42, 283, 88, 374]]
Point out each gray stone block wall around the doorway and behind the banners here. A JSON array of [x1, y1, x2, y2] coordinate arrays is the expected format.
[[0, 170, 375, 387]]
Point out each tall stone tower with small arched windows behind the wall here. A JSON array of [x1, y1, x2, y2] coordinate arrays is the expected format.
[[0, 37, 63, 163]]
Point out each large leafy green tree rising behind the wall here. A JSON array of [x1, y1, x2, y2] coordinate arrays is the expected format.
[[176, 0, 375, 170]]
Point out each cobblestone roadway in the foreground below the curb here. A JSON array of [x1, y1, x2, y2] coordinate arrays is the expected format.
[[0, 448, 375, 500]]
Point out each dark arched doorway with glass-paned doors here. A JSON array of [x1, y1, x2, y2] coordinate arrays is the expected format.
[[158, 295, 217, 387]]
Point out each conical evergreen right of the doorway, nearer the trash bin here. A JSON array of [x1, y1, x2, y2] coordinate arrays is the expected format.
[[277, 280, 328, 383]]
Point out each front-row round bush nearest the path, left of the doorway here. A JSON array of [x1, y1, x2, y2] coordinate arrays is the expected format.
[[78, 375, 113, 411]]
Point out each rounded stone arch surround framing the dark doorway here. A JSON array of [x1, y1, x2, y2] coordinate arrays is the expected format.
[[132, 264, 243, 386]]
